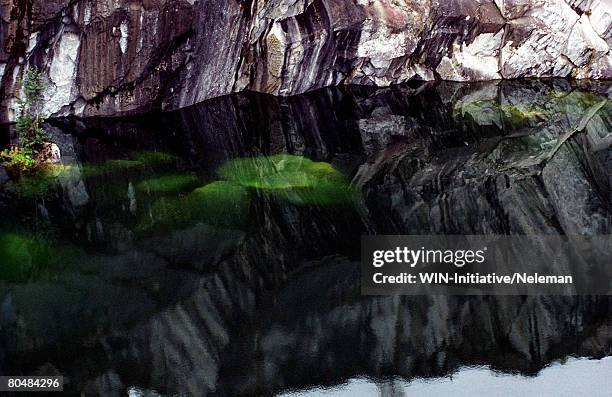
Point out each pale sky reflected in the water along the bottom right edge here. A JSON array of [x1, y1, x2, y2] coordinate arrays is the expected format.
[[279, 357, 612, 397]]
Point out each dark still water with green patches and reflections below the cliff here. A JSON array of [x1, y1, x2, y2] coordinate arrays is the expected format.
[[0, 81, 612, 396]]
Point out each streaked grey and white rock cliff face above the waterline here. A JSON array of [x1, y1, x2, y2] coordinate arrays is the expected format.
[[0, 0, 612, 121]]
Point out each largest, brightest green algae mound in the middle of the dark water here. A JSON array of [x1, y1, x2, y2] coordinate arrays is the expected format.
[[217, 154, 353, 206]]
